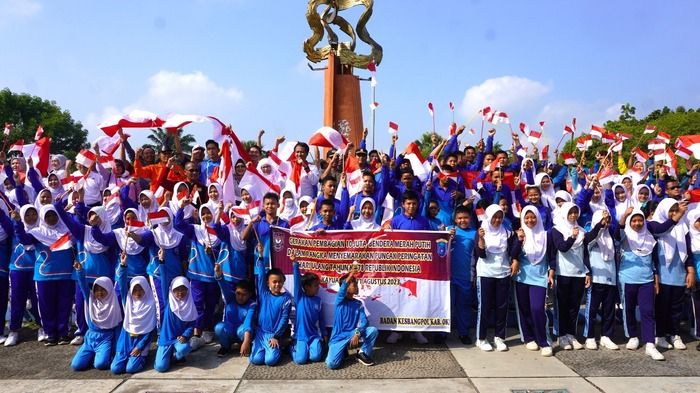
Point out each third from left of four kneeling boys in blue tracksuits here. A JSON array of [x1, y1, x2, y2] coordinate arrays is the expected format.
[[291, 261, 328, 364]]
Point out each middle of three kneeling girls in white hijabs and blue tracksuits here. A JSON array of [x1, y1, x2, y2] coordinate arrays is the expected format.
[[110, 272, 157, 374]]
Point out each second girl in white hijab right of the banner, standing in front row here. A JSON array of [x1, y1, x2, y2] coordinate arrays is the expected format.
[[513, 206, 554, 357]]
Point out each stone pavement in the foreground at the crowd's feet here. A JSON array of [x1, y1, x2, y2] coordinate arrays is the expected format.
[[0, 330, 700, 393]]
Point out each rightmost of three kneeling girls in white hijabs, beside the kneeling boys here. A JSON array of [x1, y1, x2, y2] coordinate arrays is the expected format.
[[153, 276, 198, 373]]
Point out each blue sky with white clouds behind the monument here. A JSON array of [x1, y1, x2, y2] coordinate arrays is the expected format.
[[0, 0, 700, 151]]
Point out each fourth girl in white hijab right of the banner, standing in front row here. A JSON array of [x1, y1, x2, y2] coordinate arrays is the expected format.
[[583, 210, 619, 350]]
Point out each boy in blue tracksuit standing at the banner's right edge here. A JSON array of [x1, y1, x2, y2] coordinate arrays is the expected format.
[[450, 205, 476, 345]]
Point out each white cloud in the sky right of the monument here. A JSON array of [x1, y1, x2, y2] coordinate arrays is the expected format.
[[460, 76, 552, 117]]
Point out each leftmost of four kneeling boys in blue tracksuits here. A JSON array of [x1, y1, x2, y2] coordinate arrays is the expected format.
[[214, 264, 256, 357]]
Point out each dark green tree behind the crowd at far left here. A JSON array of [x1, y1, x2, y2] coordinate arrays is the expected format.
[[0, 88, 88, 158]]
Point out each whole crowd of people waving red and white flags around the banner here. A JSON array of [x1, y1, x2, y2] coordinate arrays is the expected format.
[[0, 123, 700, 373]]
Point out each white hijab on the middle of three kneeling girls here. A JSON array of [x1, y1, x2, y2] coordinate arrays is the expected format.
[[124, 276, 156, 335]]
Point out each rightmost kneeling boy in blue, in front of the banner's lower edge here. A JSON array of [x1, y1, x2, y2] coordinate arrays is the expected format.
[[326, 265, 379, 369]]
